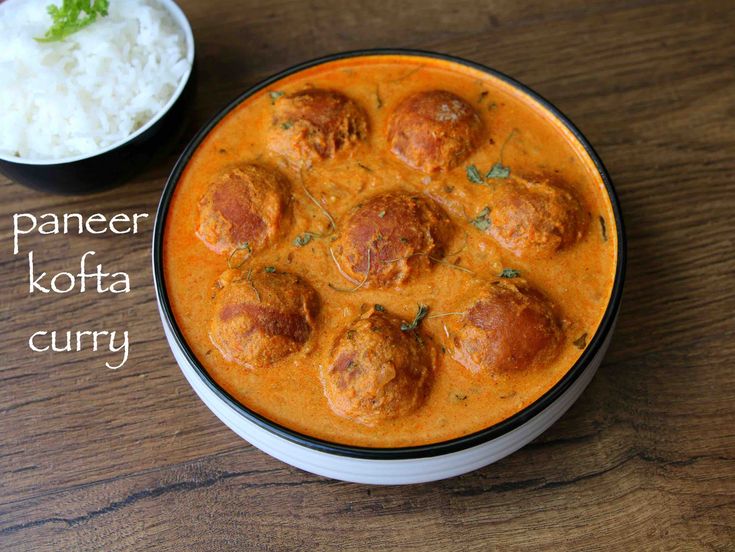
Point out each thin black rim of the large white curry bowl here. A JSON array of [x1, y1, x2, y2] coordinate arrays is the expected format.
[[153, 48, 626, 460]]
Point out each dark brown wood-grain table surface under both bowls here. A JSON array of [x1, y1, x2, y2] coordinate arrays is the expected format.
[[0, 0, 735, 550]]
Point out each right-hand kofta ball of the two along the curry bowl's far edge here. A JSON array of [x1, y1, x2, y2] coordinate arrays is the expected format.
[[388, 90, 484, 173]]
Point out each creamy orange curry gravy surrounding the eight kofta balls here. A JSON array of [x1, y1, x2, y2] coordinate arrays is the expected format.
[[164, 55, 618, 447]]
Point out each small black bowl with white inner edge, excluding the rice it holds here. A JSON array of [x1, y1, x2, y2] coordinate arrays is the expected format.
[[0, 0, 195, 195]]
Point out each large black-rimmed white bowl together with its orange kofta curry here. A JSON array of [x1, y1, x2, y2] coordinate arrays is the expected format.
[[153, 50, 625, 484]]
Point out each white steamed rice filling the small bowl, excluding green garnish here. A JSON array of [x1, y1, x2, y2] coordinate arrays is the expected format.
[[0, 0, 189, 159]]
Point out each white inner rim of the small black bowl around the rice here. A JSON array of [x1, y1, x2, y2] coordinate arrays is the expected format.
[[0, 0, 196, 166]]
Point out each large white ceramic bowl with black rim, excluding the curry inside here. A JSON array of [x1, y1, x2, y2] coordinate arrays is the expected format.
[[153, 50, 626, 485]]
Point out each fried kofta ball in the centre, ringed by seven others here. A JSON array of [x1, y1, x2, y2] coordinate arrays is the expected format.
[[333, 192, 453, 287]]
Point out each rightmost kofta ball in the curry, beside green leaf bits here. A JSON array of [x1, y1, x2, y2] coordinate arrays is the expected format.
[[490, 178, 589, 257]]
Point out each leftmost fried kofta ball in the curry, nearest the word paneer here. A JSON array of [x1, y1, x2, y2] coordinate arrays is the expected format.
[[196, 164, 291, 253]]
